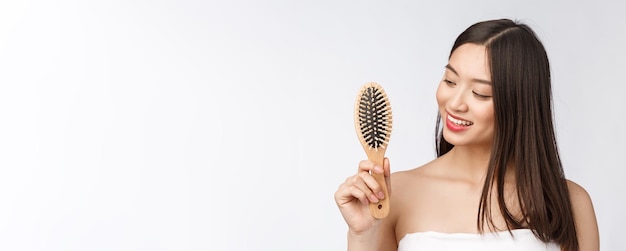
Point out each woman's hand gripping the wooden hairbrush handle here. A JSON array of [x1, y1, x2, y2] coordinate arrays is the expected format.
[[335, 158, 391, 235]]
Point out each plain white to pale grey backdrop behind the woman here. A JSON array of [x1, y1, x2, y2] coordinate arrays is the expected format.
[[0, 0, 626, 251]]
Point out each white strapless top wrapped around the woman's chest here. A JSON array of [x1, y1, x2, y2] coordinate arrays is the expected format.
[[398, 229, 561, 251]]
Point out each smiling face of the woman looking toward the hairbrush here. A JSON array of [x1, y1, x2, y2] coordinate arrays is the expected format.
[[437, 43, 495, 148]]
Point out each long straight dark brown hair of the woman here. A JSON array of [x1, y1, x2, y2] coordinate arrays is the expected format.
[[436, 19, 578, 250]]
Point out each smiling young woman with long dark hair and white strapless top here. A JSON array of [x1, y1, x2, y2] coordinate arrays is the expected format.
[[335, 19, 599, 251]]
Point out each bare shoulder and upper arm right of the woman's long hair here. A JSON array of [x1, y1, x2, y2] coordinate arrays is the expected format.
[[567, 180, 600, 250]]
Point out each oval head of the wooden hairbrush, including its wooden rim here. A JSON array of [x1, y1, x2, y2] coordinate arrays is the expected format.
[[354, 82, 392, 152]]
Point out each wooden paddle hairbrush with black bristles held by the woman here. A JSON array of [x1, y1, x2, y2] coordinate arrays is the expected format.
[[354, 82, 392, 219]]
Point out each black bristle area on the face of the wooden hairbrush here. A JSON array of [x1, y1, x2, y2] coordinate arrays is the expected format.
[[358, 87, 390, 149]]
